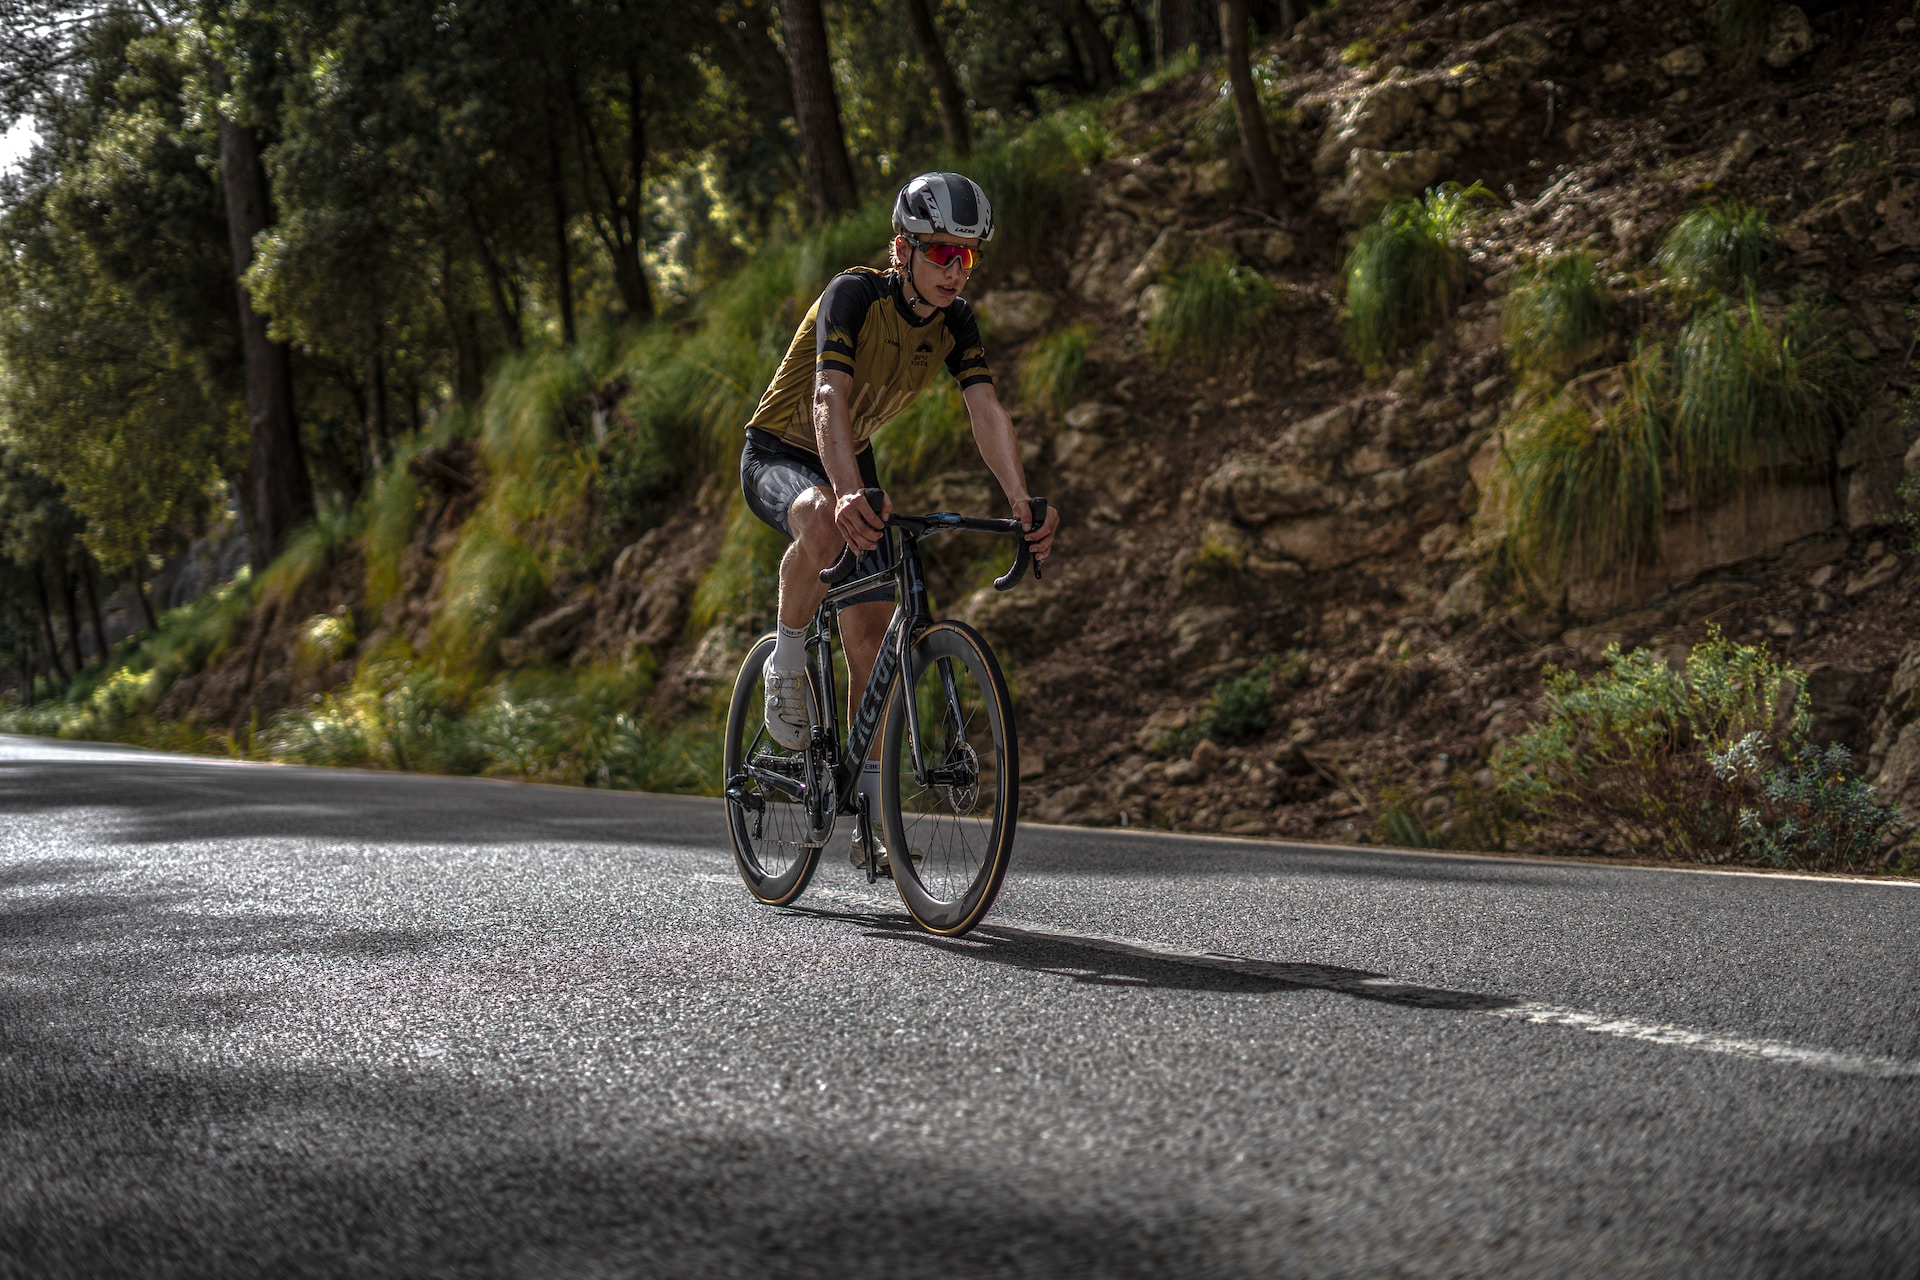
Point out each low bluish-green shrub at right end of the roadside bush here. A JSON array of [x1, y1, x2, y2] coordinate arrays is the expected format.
[[1711, 731, 1901, 869]]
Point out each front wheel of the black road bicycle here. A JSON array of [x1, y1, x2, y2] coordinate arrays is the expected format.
[[879, 622, 1020, 936]]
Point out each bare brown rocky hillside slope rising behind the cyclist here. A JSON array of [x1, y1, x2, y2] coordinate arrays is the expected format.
[[142, 0, 1920, 852]]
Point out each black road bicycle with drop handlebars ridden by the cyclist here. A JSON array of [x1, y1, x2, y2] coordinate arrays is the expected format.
[[724, 489, 1046, 936]]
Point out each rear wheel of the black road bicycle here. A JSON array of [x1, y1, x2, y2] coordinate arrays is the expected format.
[[722, 635, 826, 906]]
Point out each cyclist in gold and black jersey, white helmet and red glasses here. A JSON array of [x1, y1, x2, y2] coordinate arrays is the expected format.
[[739, 173, 1060, 865]]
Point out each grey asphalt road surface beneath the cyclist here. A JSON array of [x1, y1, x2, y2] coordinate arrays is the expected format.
[[0, 739, 1920, 1278]]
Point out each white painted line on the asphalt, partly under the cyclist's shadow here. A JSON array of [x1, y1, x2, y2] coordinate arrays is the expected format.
[[695, 873, 1920, 1080]]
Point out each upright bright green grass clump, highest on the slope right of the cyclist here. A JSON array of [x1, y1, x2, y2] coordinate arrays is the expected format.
[[1342, 182, 1484, 372]]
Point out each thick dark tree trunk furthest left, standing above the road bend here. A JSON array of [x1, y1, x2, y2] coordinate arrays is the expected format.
[[213, 61, 313, 570]]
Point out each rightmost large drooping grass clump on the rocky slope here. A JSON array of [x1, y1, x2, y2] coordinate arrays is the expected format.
[[1672, 292, 1864, 501]]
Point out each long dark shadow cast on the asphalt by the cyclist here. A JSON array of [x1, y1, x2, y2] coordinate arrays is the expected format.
[[787, 908, 1521, 1013]]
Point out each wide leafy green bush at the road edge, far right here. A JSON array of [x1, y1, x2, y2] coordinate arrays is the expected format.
[[1494, 631, 1880, 865]]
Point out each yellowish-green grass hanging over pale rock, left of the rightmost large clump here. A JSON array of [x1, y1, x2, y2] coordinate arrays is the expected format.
[[1507, 347, 1665, 578]]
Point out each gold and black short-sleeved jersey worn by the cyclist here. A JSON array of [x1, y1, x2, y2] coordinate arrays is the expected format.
[[747, 267, 993, 453]]
